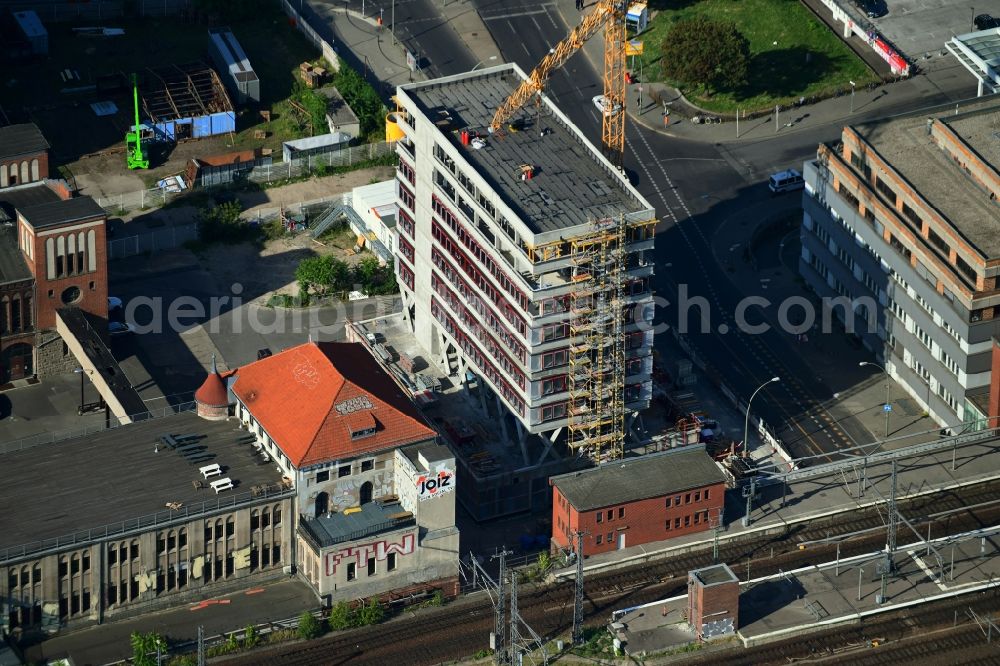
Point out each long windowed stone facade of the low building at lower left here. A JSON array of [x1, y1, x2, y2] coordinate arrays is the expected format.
[[0, 498, 294, 634]]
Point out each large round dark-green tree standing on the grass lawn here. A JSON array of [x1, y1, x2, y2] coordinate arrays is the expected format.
[[662, 16, 750, 91]]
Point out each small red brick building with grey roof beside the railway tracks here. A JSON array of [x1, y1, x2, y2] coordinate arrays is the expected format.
[[549, 446, 726, 557]]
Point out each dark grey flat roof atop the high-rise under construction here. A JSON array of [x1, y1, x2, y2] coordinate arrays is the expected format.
[[399, 64, 653, 234]]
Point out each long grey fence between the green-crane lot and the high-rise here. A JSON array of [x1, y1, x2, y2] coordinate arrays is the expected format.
[[94, 142, 396, 215]]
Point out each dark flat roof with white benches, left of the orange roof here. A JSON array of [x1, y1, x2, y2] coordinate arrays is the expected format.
[[0, 412, 290, 549]]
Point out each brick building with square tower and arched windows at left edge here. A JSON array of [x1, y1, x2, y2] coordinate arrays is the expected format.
[[0, 181, 108, 383]]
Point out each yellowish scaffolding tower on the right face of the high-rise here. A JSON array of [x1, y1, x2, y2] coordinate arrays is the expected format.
[[567, 215, 655, 463]]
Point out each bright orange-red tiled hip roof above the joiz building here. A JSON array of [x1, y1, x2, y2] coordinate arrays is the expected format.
[[232, 342, 436, 467]]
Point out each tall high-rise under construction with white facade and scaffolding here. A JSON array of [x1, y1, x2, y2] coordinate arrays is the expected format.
[[387, 65, 655, 482]]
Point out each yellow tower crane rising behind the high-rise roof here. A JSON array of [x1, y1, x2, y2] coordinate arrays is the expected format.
[[490, 0, 625, 168]]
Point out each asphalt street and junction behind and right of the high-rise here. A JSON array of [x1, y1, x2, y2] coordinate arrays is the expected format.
[[364, 0, 972, 456]]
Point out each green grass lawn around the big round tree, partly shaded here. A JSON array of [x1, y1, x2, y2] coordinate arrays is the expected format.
[[629, 0, 878, 113]]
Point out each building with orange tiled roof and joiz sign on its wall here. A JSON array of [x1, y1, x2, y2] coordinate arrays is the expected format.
[[230, 342, 459, 603]]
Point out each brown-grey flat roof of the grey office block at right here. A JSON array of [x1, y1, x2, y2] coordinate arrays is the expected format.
[[853, 98, 1000, 258]]
